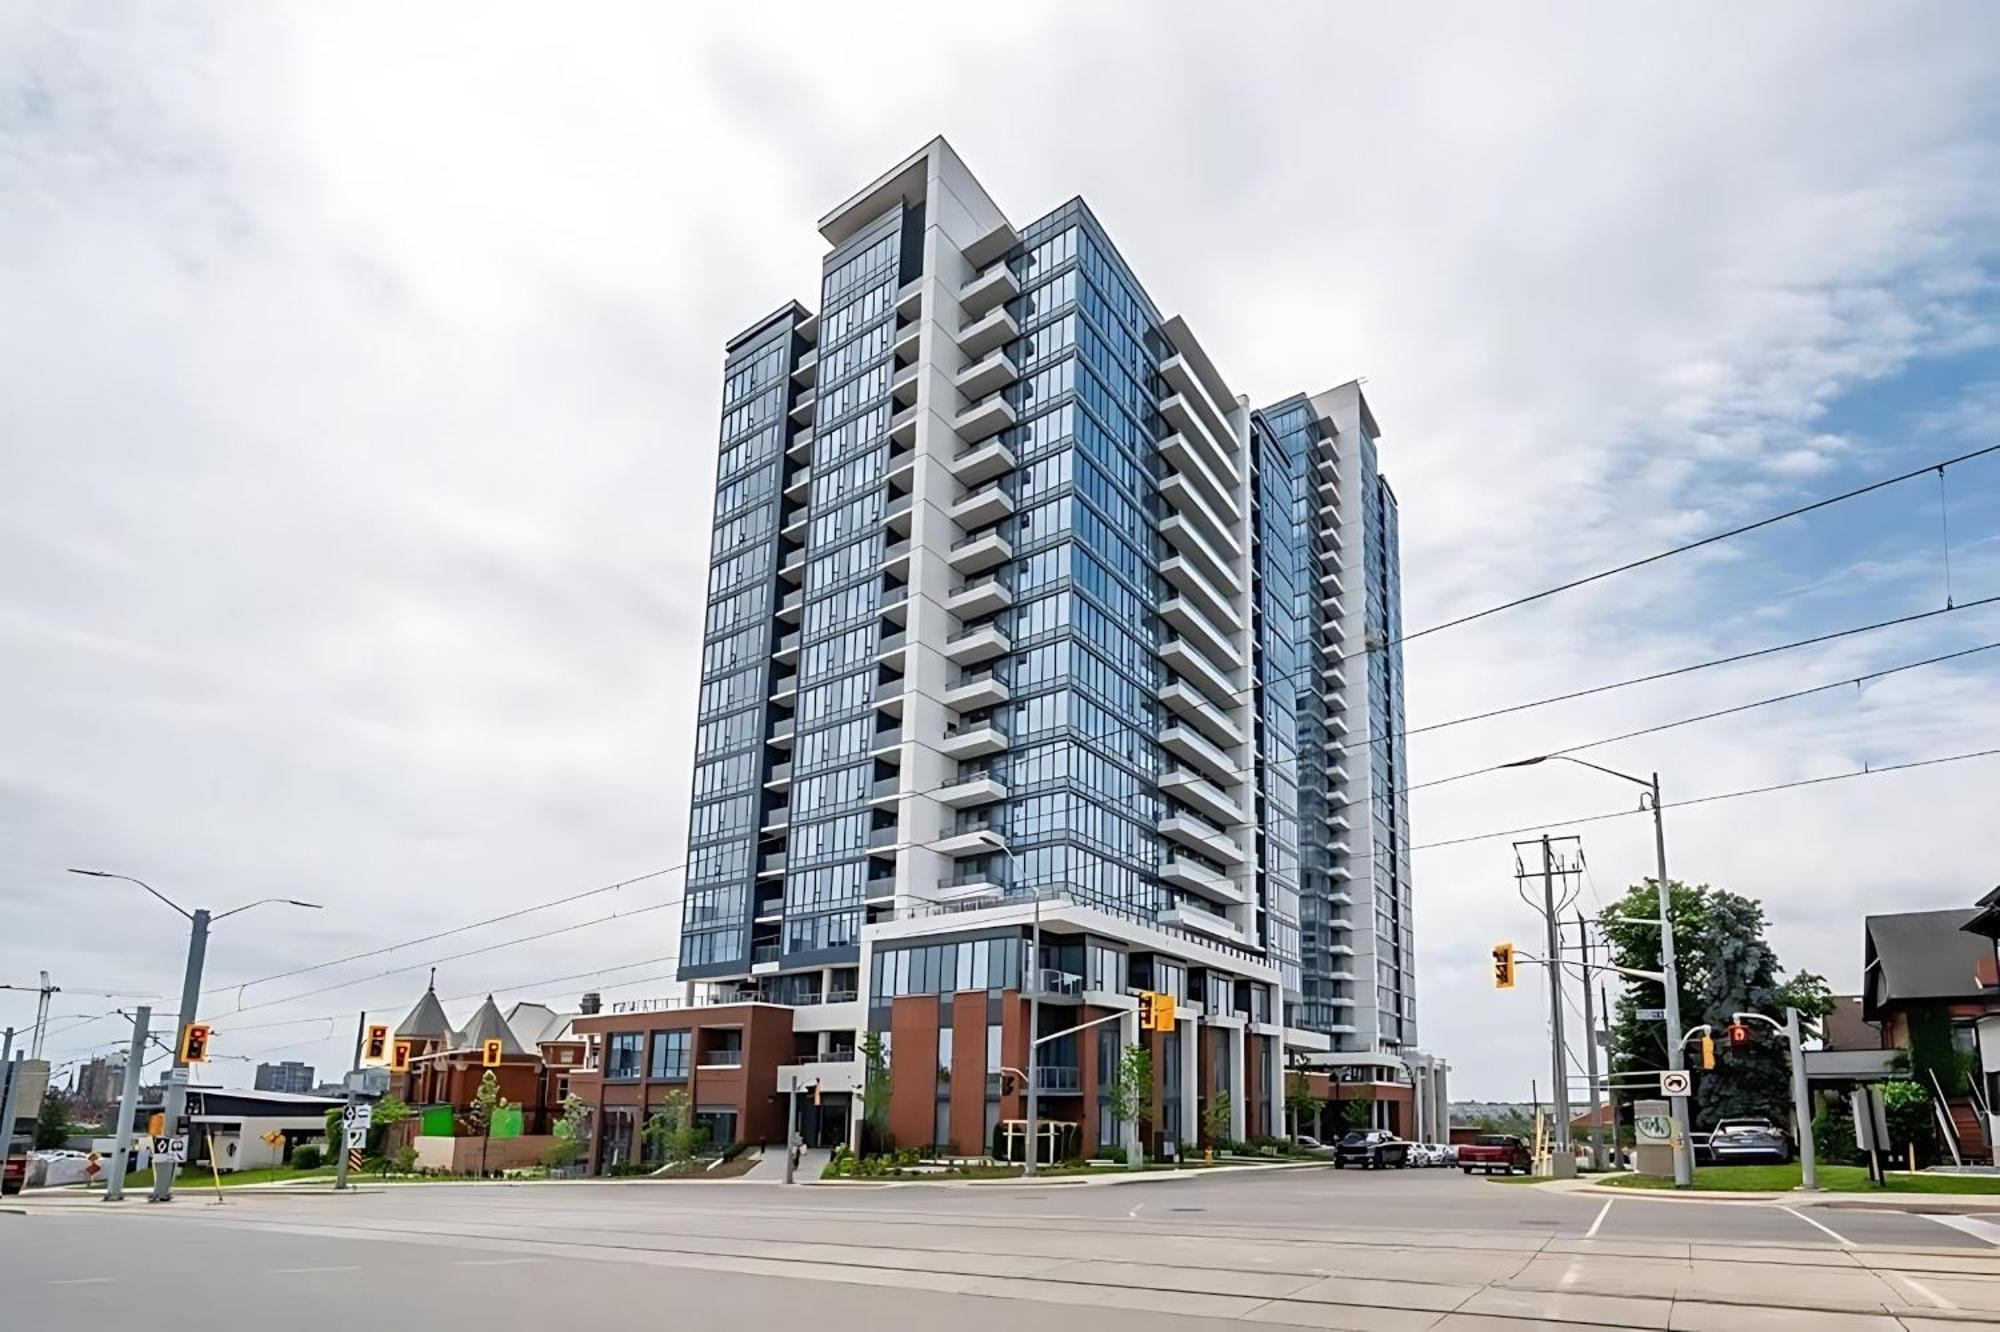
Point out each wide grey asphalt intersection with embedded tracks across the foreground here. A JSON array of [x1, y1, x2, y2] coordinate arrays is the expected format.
[[0, 1170, 2000, 1332]]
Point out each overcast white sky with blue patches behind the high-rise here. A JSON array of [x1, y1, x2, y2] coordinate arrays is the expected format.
[[11, 0, 2000, 1098]]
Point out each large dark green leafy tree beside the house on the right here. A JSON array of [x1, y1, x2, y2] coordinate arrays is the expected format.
[[1604, 880, 1834, 1128]]
